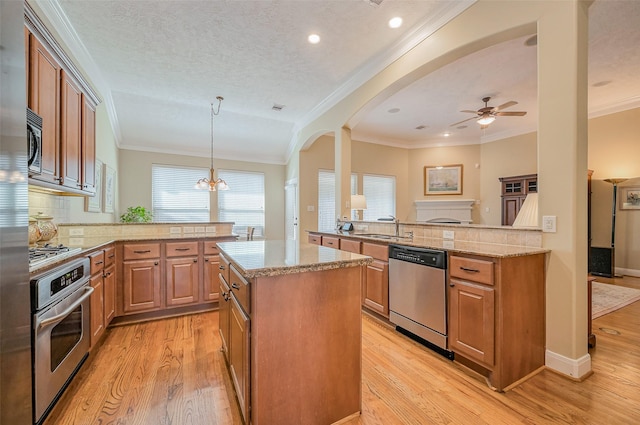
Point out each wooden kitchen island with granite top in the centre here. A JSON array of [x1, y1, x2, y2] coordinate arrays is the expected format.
[[218, 241, 372, 425]]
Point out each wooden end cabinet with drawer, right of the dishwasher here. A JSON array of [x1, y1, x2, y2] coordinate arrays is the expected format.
[[448, 254, 545, 391]]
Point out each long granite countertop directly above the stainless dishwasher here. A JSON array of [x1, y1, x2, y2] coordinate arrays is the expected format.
[[308, 230, 550, 258]]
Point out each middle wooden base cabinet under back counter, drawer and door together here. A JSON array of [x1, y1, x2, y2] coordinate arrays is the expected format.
[[165, 242, 200, 306]]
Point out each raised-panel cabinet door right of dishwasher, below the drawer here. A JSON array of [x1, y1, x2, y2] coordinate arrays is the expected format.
[[449, 278, 495, 367]]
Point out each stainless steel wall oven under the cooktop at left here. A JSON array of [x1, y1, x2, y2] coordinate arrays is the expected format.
[[31, 258, 93, 424]]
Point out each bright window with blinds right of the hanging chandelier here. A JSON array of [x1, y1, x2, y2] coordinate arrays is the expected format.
[[216, 170, 265, 237]]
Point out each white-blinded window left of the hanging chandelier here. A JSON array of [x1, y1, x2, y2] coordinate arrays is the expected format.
[[151, 164, 210, 222]]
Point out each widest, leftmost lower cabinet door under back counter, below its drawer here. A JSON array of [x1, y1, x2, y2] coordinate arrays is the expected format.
[[122, 260, 161, 313]]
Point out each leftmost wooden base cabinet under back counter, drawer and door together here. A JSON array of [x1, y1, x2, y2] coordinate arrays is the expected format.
[[122, 243, 161, 314]]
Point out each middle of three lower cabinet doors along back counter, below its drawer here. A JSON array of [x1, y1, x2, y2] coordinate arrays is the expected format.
[[165, 257, 200, 306]]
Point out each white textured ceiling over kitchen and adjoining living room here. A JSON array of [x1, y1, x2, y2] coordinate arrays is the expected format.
[[38, 0, 640, 163]]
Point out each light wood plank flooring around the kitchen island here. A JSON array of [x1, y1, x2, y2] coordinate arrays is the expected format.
[[45, 278, 640, 425]]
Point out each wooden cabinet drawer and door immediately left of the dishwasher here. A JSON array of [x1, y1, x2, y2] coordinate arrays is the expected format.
[[362, 242, 389, 317]]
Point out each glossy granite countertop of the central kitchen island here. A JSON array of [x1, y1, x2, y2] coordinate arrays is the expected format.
[[218, 240, 373, 279]]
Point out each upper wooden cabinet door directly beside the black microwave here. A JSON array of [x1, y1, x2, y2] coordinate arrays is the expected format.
[[29, 34, 60, 184]]
